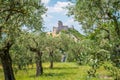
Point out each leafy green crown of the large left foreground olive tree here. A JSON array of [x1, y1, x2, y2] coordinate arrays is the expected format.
[[0, 0, 45, 39]]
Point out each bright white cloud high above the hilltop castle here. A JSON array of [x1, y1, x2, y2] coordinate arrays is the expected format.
[[47, 1, 72, 13]]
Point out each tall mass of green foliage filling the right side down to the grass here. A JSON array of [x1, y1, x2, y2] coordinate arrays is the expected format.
[[68, 0, 120, 80]]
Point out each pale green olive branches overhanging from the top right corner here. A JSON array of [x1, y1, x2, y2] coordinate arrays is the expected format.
[[68, 0, 120, 36]]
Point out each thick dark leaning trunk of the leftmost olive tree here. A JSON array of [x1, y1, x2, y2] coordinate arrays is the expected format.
[[0, 43, 15, 80]]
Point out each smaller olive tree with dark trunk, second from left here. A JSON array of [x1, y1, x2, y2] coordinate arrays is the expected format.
[[26, 33, 46, 76]]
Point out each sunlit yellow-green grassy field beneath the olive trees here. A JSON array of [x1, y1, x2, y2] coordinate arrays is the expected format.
[[0, 62, 113, 80]]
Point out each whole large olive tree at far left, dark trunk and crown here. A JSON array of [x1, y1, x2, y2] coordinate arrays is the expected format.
[[0, 0, 45, 80]]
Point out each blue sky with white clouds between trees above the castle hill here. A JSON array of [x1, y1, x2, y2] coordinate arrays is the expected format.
[[41, 0, 82, 33]]
